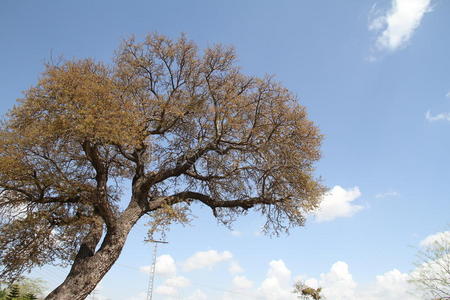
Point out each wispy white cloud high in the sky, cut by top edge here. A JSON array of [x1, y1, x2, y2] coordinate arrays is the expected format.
[[369, 0, 431, 51]]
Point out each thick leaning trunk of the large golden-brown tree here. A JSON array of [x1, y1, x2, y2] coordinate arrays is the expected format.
[[45, 207, 141, 300]]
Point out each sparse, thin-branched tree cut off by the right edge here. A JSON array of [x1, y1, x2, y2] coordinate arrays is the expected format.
[[410, 231, 450, 299]]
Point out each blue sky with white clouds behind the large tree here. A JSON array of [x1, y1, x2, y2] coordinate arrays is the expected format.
[[0, 0, 450, 300]]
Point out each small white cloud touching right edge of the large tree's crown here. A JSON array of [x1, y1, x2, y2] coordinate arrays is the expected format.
[[315, 185, 363, 222]]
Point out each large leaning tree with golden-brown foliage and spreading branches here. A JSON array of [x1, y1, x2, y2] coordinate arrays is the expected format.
[[0, 34, 324, 300]]
